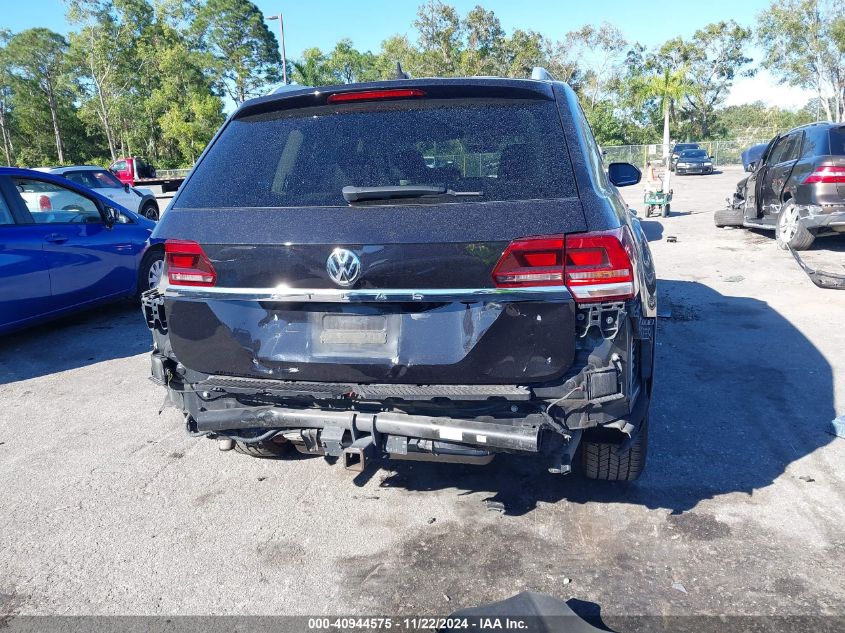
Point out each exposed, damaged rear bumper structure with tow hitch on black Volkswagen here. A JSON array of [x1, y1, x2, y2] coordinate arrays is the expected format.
[[143, 292, 654, 472]]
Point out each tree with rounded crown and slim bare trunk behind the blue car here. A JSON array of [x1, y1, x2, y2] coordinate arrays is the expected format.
[[5, 28, 69, 163]]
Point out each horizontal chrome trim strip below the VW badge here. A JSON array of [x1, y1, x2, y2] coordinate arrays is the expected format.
[[162, 285, 572, 303]]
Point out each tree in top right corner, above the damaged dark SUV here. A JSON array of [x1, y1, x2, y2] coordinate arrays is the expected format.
[[757, 0, 845, 121]]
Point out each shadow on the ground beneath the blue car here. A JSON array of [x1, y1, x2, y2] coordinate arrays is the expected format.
[[0, 301, 152, 384]]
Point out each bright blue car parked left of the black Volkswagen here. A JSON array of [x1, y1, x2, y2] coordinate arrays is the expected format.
[[0, 167, 164, 333]]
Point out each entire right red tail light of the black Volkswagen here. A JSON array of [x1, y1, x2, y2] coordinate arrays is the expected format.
[[493, 227, 636, 303]]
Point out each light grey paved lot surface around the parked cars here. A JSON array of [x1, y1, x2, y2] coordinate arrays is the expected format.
[[0, 168, 845, 624]]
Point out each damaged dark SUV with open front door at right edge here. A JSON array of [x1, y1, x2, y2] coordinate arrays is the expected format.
[[715, 123, 845, 250]]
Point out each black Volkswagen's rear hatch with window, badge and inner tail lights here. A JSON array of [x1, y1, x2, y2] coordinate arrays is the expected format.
[[156, 80, 587, 384]]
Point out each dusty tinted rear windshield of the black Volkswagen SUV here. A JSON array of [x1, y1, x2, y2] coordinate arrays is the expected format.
[[175, 99, 576, 208]]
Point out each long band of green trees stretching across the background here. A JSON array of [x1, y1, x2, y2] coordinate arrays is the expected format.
[[0, 0, 824, 168]]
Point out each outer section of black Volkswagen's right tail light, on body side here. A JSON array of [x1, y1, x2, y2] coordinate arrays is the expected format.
[[564, 227, 637, 303]]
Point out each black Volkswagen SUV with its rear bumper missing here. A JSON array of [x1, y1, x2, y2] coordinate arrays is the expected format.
[[144, 74, 656, 480]]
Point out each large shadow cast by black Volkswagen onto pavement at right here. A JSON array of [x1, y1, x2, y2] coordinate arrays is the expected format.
[[356, 281, 835, 515]]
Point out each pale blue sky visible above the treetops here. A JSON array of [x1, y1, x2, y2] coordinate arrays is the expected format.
[[0, 0, 814, 108]]
